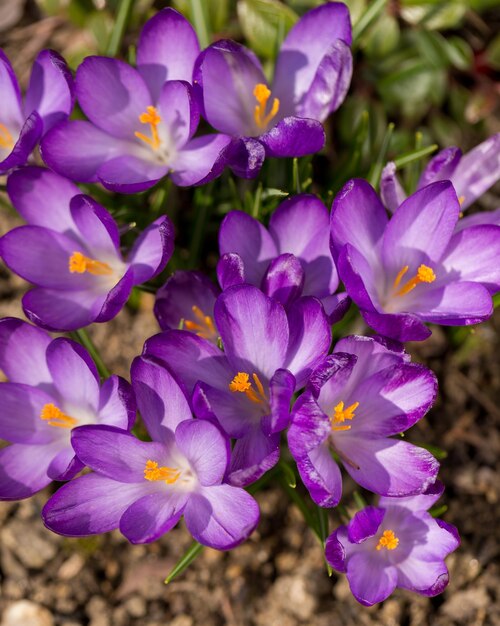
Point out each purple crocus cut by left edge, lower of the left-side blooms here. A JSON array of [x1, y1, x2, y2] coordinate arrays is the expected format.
[[0, 318, 135, 500]]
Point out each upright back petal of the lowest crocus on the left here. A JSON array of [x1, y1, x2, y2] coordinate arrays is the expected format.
[[131, 357, 193, 441]]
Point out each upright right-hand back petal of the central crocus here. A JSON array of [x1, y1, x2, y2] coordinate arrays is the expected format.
[[285, 297, 332, 389]]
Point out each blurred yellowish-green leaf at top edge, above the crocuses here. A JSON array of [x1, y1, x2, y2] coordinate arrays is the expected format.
[[237, 0, 299, 59]]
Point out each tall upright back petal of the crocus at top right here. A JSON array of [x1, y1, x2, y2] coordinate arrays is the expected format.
[[274, 2, 352, 119]]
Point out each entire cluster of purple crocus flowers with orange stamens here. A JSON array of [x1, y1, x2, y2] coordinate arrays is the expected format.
[[0, 2, 500, 605]]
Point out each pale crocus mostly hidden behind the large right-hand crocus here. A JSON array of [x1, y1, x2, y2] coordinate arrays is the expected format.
[[380, 133, 500, 212]]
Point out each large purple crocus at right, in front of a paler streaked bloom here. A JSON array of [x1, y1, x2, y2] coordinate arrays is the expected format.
[[331, 180, 500, 341]]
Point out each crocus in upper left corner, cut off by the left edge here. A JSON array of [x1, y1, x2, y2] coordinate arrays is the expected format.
[[0, 50, 74, 175]]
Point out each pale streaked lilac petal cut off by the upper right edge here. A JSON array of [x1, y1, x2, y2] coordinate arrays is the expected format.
[[451, 133, 500, 209]]
